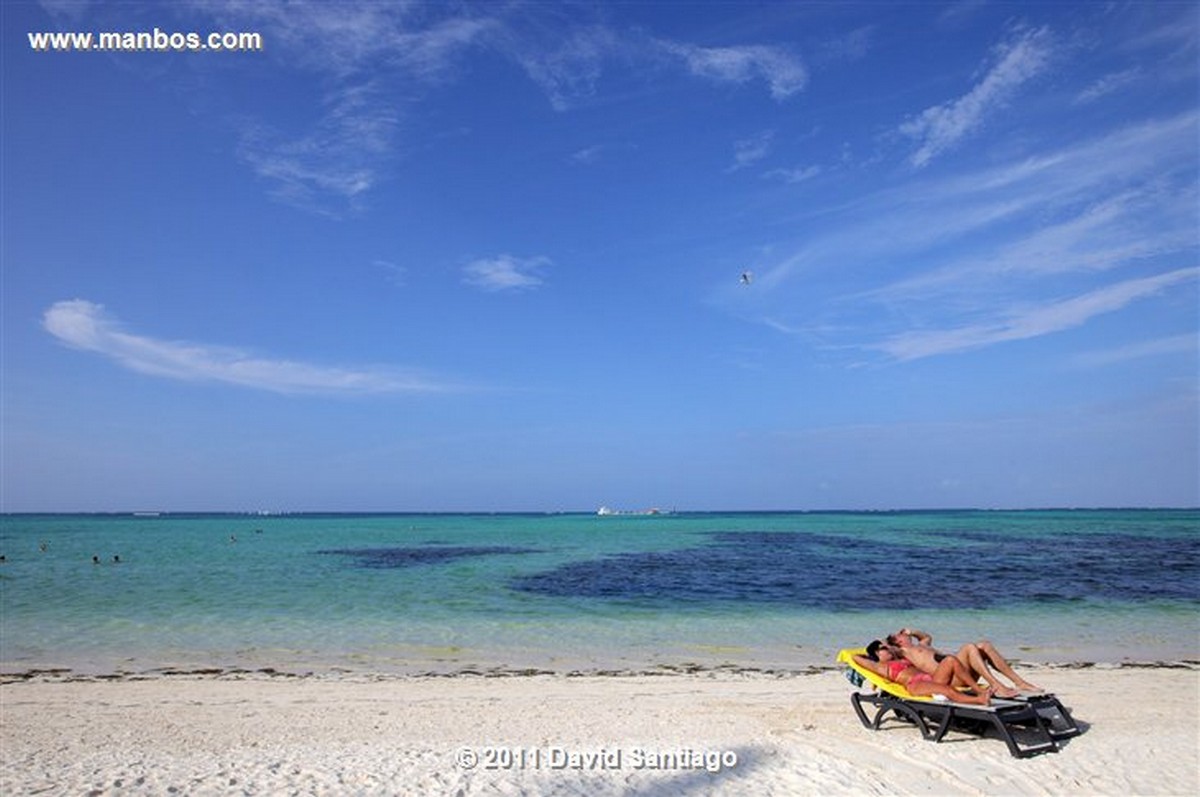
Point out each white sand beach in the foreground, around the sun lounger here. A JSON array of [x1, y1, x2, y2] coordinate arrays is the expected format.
[[0, 665, 1200, 796]]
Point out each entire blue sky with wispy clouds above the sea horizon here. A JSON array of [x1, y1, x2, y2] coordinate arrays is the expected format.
[[0, 0, 1200, 511]]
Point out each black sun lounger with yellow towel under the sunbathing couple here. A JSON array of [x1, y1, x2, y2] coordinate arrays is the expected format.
[[838, 648, 1080, 759]]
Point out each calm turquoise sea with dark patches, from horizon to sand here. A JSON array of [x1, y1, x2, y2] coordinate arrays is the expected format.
[[0, 510, 1200, 672]]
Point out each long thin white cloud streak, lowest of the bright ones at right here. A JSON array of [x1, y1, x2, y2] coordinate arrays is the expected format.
[[878, 268, 1200, 360]]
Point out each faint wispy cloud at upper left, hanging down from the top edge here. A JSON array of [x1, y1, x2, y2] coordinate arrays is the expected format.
[[192, 0, 492, 215]]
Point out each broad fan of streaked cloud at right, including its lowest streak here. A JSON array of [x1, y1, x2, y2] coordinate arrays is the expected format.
[[739, 113, 1200, 359]]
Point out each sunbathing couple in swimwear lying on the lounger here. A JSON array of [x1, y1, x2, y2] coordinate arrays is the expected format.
[[854, 628, 1039, 706]]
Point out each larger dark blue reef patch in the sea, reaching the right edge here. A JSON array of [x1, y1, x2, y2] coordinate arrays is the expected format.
[[511, 532, 1200, 611]]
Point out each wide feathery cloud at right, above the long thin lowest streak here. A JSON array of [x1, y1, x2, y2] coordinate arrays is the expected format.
[[782, 113, 1200, 305]]
